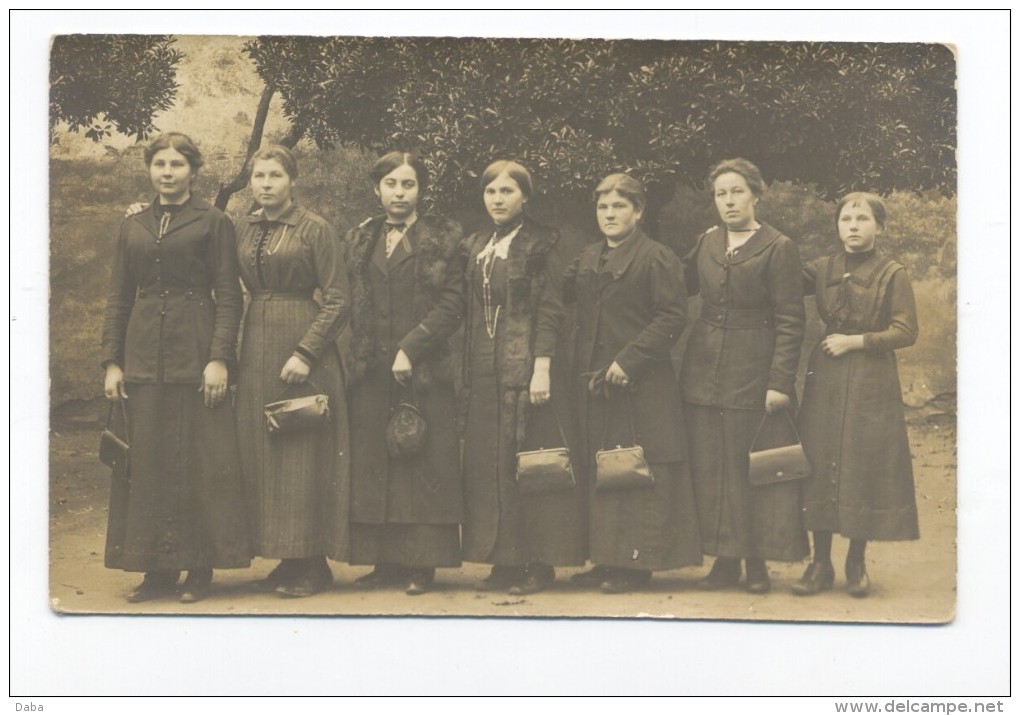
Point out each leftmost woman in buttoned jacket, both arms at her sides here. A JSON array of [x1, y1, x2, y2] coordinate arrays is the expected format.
[[102, 133, 252, 602]]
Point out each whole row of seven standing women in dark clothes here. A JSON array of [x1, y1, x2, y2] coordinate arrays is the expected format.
[[103, 133, 917, 602]]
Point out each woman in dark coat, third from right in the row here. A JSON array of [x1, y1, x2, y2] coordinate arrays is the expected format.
[[564, 174, 702, 594]]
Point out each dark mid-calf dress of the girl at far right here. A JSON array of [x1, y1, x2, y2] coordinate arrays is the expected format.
[[800, 252, 919, 540]]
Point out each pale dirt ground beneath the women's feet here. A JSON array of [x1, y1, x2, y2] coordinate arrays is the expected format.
[[50, 406, 957, 623]]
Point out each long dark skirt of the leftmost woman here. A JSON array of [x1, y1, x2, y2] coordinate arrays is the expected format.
[[105, 383, 253, 572]]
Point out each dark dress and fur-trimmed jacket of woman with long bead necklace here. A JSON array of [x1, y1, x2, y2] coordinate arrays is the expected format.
[[463, 219, 587, 565]]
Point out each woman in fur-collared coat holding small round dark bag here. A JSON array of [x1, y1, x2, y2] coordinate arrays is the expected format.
[[344, 152, 464, 595]]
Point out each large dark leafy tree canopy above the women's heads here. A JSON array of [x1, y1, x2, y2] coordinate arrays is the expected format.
[[245, 37, 956, 216]]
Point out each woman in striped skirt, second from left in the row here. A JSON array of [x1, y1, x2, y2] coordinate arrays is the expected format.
[[238, 146, 350, 597]]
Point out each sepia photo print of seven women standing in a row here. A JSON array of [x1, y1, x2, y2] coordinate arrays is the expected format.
[[11, 5, 1007, 694]]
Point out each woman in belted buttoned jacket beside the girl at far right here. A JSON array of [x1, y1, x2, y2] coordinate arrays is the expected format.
[[681, 159, 807, 594]]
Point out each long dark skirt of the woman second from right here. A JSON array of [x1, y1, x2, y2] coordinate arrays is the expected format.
[[686, 403, 808, 562]]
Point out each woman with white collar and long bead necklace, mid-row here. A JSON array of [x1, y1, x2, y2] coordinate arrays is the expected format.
[[463, 161, 585, 595]]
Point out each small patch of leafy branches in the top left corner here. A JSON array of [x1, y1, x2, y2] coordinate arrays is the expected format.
[[50, 35, 184, 142]]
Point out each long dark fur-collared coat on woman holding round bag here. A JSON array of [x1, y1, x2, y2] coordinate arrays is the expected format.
[[344, 215, 464, 524]]
